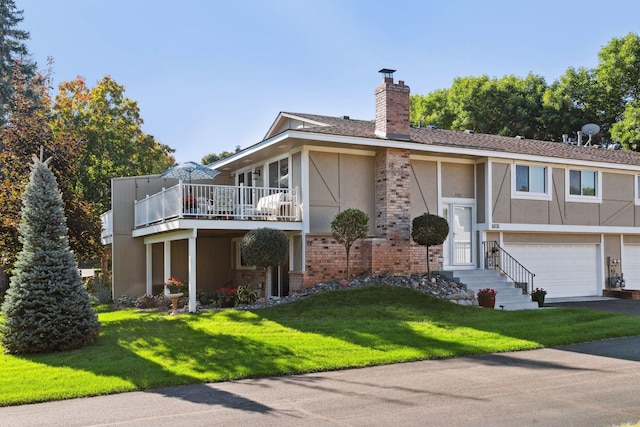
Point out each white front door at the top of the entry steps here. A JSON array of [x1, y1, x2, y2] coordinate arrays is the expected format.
[[442, 203, 473, 266]]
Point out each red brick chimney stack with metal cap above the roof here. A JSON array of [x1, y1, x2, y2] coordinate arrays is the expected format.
[[376, 68, 411, 141]]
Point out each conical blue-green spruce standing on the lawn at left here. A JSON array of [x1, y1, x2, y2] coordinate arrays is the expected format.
[[0, 155, 100, 353]]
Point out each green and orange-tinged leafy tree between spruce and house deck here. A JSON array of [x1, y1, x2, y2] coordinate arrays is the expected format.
[[53, 76, 174, 216]]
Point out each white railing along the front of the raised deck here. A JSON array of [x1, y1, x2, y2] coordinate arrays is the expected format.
[[134, 183, 300, 228]]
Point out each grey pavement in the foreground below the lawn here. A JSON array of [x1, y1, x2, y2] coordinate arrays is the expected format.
[[0, 303, 640, 427]]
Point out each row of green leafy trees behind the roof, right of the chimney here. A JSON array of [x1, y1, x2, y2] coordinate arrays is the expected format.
[[410, 33, 640, 150]]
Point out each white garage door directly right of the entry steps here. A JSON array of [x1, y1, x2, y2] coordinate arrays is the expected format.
[[505, 245, 599, 298]]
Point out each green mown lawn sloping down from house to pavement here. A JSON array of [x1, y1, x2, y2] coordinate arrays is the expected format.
[[0, 286, 640, 406]]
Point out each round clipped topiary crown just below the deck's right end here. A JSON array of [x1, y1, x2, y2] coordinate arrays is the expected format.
[[240, 228, 289, 268]]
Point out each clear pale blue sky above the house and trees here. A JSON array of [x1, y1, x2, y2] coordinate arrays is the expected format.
[[15, 0, 640, 162]]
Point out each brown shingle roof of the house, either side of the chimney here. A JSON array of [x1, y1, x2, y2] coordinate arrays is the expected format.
[[283, 113, 640, 166]]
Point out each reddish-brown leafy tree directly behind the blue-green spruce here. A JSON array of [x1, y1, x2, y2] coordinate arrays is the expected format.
[[0, 70, 95, 294]]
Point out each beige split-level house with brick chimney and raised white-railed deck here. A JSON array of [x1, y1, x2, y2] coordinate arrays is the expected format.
[[103, 70, 640, 307]]
